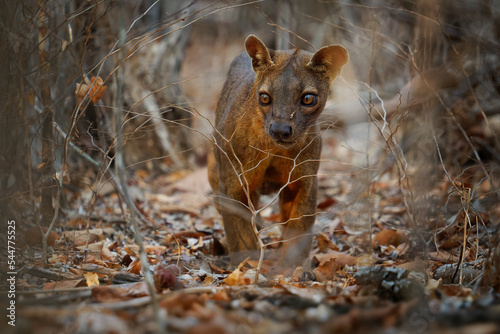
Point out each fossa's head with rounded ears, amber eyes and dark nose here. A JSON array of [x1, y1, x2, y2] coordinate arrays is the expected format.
[[245, 35, 349, 147]]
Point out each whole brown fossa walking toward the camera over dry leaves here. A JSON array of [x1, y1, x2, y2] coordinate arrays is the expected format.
[[208, 35, 348, 267]]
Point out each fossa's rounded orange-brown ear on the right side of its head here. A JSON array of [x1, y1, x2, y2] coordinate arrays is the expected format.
[[307, 45, 349, 82]]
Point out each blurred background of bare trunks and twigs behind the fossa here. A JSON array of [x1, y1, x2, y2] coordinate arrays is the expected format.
[[0, 0, 500, 249]]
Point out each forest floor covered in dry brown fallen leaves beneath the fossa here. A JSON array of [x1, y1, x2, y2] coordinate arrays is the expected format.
[[1, 129, 500, 334]]
